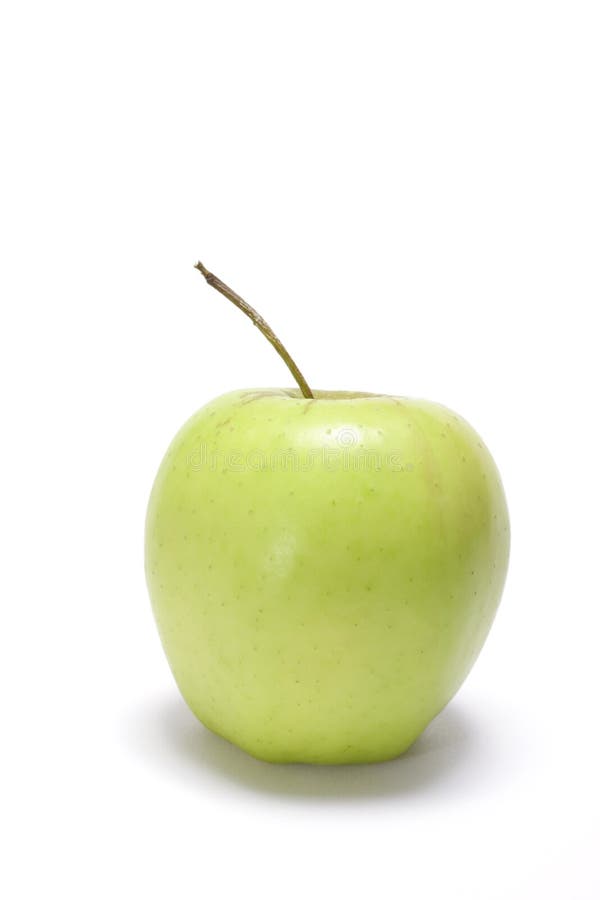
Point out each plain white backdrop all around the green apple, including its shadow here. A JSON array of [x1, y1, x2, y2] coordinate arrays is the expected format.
[[0, 0, 600, 900]]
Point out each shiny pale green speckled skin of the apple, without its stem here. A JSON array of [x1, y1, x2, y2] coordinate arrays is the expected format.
[[146, 389, 509, 764]]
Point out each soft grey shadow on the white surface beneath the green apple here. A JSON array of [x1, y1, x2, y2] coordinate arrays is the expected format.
[[124, 697, 485, 801]]
